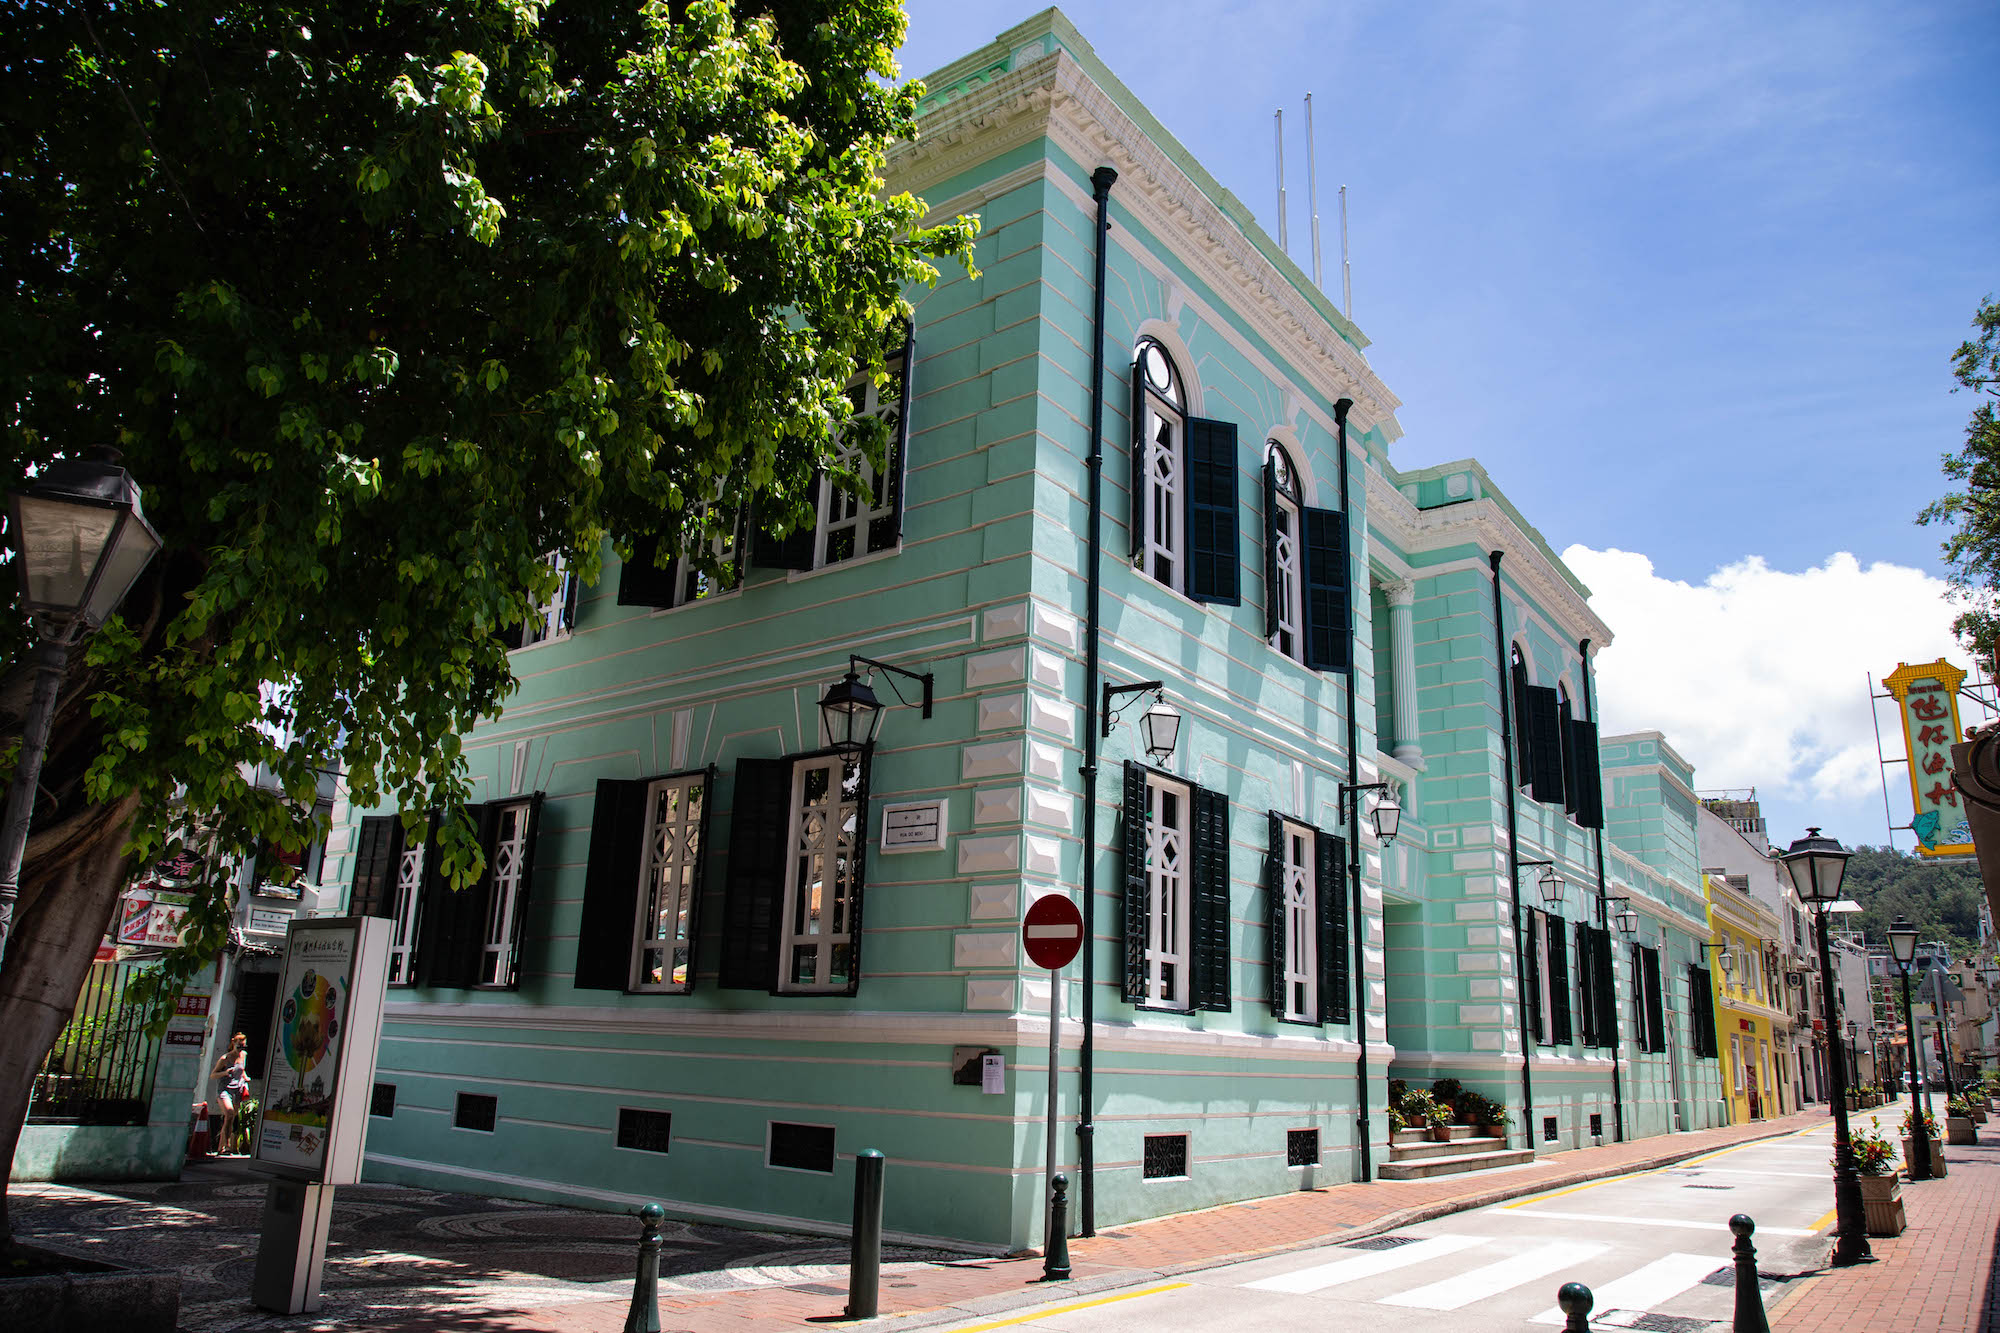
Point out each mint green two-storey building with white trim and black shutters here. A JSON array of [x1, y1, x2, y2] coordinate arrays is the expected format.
[[324, 10, 1716, 1249]]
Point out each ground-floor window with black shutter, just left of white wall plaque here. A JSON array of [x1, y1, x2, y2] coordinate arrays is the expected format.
[[722, 751, 868, 995]]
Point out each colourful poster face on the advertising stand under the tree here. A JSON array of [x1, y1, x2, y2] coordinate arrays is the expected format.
[[256, 929, 354, 1173]]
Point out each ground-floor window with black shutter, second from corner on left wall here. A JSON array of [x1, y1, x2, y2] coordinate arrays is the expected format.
[[576, 769, 716, 995]]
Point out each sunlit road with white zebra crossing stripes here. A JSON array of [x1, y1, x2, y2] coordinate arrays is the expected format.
[[958, 1121, 1848, 1333]]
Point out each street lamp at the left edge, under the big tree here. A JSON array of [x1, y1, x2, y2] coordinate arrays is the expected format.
[[0, 450, 160, 957]]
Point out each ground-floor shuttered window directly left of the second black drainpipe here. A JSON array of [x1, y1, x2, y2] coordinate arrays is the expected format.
[[1266, 811, 1350, 1025]]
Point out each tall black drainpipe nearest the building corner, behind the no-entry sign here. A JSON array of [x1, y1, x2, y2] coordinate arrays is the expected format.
[[1080, 166, 1118, 1235]]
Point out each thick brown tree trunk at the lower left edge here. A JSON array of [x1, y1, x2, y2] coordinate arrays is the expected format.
[[0, 797, 138, 1249]]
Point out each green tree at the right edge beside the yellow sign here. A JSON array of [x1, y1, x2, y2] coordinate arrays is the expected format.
[[1916, 296, 2000, 664]]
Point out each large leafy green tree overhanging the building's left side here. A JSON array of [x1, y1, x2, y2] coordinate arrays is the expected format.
[[0, 0, 976, 1237]]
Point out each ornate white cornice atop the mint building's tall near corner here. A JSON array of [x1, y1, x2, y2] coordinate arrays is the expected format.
[[888, 50, 1402, 436]]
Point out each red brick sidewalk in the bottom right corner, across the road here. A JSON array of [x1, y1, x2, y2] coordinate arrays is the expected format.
[[1770, 1125, 2000, 1333]]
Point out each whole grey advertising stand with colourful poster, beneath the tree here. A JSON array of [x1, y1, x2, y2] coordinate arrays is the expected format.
[[250, 917, 390, 1315]]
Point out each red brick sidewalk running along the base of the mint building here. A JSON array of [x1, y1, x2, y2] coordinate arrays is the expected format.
[[356, 1109, 1832, 1333]]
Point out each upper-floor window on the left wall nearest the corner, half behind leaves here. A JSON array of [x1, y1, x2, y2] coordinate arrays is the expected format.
[[752, 328, 916, 570]]
